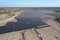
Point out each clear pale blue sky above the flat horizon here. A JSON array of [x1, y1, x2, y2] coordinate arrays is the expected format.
[[0, 0, 60, 7]]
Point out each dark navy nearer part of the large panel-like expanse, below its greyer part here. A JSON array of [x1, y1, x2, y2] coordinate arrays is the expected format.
[[0, 18, 46, 33]]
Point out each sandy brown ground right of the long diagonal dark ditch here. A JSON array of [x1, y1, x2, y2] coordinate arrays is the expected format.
[[37, 19, 60, 40]]
